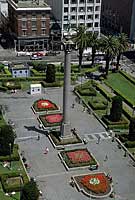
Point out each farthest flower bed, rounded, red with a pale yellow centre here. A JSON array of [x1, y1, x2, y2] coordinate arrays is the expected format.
[[33, 99, 59, 112]]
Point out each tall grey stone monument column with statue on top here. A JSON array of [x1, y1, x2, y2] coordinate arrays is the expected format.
[[61, 33, 73, 137]]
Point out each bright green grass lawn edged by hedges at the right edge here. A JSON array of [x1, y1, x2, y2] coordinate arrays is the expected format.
[[105, 73, 135, 105]]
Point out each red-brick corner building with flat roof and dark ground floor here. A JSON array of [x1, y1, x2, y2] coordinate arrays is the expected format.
[[8, 0, 51, 51]]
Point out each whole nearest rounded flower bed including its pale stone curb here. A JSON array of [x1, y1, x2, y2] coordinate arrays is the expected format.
[[73, 172, 112, 197]]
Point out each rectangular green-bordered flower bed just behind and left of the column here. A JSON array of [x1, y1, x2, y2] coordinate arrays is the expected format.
[[39, 113, 63, 127]]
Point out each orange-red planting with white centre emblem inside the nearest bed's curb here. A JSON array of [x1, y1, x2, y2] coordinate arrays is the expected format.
[[81, 173, 109, 194]]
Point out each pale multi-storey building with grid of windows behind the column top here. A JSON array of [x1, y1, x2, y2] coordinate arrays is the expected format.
[[47, 0, 101, 36]]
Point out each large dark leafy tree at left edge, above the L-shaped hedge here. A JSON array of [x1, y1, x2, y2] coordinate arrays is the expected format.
[[0, 125, 16, 156]]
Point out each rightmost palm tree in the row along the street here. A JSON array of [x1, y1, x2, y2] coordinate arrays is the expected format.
[[117, 33, 128, 69]]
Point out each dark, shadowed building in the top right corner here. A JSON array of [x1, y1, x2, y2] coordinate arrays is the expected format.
[[101, 0, 135, 40]]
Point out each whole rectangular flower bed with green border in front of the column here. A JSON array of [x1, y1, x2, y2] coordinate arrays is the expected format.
[[60, 149, 97, 168]]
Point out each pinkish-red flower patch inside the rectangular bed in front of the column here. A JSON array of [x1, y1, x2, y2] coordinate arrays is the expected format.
[[67, 150, 92, 163]]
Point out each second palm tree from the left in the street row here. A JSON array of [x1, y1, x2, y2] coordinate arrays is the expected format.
[[88, 32, 99, 65]]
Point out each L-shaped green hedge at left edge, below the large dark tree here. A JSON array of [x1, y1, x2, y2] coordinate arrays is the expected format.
[[0, 144, 20, 161]]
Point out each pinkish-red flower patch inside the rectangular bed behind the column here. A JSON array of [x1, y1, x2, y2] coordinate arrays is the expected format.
[[45, 114, 63, 124]]
